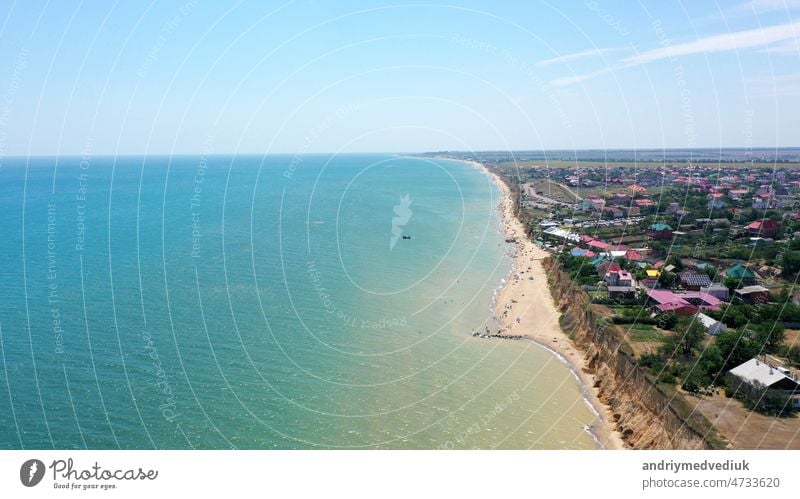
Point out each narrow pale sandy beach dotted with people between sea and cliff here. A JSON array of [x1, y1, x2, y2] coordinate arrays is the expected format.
[[443, 158, 624, 449]]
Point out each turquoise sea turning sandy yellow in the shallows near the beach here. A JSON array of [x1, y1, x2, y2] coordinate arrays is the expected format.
[[0, 155, 595, 449]]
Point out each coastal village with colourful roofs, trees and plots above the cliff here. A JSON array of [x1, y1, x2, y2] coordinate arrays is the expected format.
[[424, 149, 800, 448]]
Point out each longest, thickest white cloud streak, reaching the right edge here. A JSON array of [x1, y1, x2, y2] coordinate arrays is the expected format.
[[550, 21, 800, 86]]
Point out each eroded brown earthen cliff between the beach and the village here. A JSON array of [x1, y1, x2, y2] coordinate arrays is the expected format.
[[544, 259, 710, 449]]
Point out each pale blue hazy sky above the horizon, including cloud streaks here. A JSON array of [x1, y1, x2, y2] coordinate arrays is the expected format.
[[0, 0, 800, 158]]
